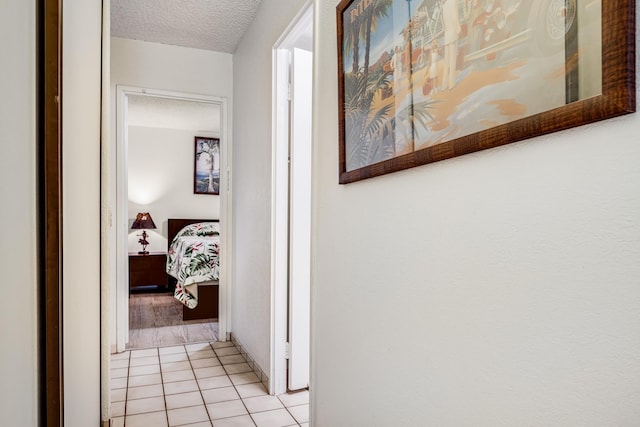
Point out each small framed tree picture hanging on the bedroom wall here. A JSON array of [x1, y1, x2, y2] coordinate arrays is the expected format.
[[193, 136, 220, 195]]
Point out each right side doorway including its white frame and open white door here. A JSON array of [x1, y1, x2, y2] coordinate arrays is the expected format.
[[270, 4, 313, 394]]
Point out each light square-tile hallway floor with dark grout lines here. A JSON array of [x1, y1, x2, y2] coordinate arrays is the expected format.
[[111, 342, 309, 427]]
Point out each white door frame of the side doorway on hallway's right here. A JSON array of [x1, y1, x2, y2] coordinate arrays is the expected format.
[[269, 1, 313, 394]]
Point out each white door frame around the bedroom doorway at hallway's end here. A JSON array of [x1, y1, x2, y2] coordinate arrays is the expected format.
[[114, 85, 232, 352]]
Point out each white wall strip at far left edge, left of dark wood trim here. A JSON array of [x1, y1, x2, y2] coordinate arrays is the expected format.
[[0, 0, 38, 426]]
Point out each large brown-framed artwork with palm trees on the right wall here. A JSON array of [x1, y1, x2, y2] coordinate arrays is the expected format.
[[337, 0, 636, 184]]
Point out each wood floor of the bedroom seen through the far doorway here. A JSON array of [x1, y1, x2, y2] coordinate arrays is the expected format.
[[127, 293, 218, 349]]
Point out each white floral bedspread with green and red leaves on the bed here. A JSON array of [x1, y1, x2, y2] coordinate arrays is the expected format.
[[167, 222, 220, 308]]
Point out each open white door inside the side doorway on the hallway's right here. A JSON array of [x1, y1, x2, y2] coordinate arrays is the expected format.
[[287, 49, 313, 390]]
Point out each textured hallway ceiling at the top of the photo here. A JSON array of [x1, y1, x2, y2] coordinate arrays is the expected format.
[[111, 0, 261, 53]]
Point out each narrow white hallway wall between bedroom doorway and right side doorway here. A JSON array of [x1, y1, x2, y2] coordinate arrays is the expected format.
[[232, 0, 305, 382]]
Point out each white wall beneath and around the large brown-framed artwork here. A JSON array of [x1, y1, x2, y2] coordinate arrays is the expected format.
[[311, 0, 640, 427]]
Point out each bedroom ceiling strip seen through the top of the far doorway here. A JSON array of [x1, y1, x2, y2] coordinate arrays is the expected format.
[[127, 95, 220, 132]]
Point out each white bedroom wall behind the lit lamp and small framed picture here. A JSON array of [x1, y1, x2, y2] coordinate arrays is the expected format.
[[127, 126, 220, 252]]
